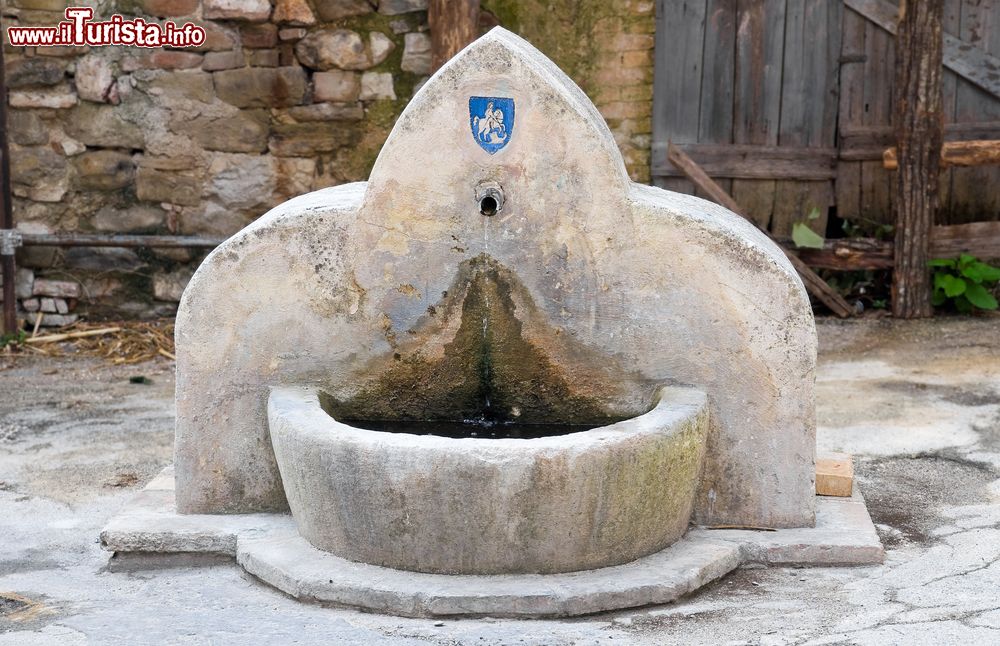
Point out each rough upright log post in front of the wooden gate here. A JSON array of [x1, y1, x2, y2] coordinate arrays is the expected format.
[[892, 0, 944, 318]]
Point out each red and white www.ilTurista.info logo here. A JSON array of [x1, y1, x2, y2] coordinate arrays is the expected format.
[[7, 7, 205, 47]]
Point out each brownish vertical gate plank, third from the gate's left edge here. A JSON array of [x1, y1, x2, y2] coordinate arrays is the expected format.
[[732, 0, 786, 229]]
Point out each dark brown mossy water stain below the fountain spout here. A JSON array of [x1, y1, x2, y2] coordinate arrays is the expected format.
[[322, 254, 644, 426]]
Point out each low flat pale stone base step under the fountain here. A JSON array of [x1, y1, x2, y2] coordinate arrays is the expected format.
[[101, 467, 884, 617]]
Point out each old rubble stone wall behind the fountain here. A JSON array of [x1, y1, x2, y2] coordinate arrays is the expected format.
[[3, 0, 654, 317]]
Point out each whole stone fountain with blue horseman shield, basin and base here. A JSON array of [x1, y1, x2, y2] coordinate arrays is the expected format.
[[102, 28, 882, 616]]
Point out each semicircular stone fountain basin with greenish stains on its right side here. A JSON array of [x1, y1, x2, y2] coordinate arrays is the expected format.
[[268, 387, 709, 574]]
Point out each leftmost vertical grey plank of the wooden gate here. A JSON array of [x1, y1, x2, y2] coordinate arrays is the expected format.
[[652, 0, 707, 193]]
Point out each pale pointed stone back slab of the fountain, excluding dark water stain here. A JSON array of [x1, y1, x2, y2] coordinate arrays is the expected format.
[[176, 29, 816, 527]]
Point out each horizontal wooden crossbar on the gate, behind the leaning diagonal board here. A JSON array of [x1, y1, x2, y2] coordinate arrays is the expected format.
[[653, 144, 837, 180]]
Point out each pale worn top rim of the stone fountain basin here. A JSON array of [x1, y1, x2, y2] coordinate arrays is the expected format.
[[268, 386, 708, 453]]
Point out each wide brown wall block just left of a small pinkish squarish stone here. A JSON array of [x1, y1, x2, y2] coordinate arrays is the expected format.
[[213, 67, 306, 108]]
